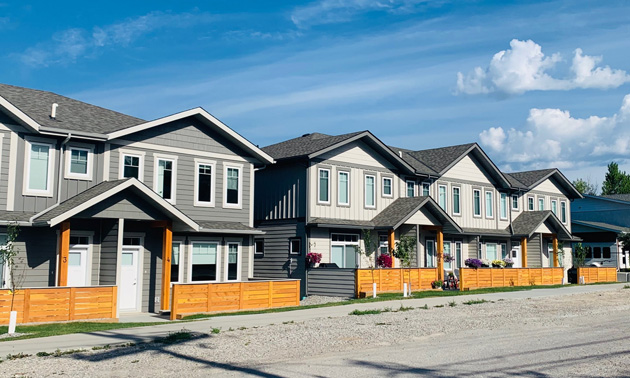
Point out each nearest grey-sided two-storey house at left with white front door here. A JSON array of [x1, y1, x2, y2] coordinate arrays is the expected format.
[[0, 85, 273, 312]]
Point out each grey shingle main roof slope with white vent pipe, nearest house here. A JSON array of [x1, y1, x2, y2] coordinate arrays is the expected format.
[[0, 84, 145, 134]]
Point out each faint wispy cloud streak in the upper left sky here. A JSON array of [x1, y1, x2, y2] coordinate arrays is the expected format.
[[14, 12, 213, 67]]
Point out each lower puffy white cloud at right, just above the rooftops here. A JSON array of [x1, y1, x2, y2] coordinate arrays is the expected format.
[[479, 94, 630, 170]]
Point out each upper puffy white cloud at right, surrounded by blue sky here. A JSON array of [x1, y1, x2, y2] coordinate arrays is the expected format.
[[457, 39, 630, 95]]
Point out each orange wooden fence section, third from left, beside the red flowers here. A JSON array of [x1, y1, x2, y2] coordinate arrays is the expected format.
[[355, 268, 437, 297]]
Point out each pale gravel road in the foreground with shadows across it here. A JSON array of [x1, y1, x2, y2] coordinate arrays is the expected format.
[[0, 289, 630, 377]]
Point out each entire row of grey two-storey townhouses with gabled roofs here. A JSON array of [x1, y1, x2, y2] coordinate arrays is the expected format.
[[0, 84, 581, 312]]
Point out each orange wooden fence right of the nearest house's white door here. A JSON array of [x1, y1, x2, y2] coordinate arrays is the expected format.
[[171, 280, 300, 320]]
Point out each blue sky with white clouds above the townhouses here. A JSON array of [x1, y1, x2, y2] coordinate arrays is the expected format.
[[0, 0, 630, 188]]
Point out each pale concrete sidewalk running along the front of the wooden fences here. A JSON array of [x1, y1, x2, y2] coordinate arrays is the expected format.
[[0, 283, 624, 356]]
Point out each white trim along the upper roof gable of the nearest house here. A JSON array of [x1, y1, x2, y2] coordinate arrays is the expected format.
[[107, 108, 274, 164]]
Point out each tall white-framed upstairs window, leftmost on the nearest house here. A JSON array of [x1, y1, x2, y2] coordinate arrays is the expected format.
[[24, 141, 54, 196]]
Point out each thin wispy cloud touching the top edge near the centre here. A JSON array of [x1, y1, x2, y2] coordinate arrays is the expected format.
[[291, 0, 436, 28]]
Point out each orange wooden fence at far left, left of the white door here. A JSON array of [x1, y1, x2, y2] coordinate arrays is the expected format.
[[0, 286, 117, 324]]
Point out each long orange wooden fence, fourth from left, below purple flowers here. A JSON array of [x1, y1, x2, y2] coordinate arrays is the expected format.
[[459, 268, 564, 290]]
